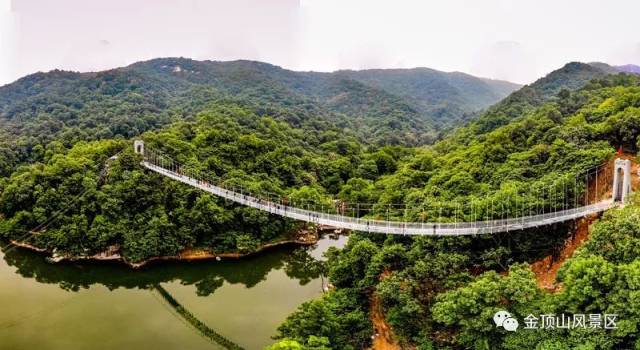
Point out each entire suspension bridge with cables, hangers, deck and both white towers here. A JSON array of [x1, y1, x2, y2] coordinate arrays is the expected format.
[[134, 141, 631, 236]]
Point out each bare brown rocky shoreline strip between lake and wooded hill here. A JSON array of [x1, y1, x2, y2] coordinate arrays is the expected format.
[[10, 230, 319, 269]]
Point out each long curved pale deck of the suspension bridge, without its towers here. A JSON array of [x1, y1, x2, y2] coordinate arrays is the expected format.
[[142, 161, 616, 236]]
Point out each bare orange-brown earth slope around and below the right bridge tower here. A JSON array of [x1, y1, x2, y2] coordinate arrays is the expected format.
[[531, 153, 640, 293]]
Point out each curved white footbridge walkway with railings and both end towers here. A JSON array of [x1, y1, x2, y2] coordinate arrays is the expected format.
[[134, 141, 631, 236]]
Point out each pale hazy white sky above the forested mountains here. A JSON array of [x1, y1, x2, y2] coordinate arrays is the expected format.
[[0, 0, 640, 85]]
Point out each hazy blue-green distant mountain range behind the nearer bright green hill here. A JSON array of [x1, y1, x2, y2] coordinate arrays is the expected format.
[[0, 58, 517, 149]]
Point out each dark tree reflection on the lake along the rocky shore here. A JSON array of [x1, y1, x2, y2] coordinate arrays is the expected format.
[[4, 243, 324, 296]]
